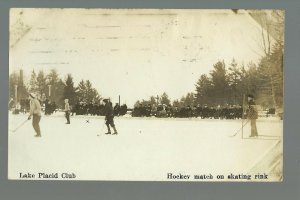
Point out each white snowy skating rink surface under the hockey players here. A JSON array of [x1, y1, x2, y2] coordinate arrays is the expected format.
[[8, 113, 283, 181]]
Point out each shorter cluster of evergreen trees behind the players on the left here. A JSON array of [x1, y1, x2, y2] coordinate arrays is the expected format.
[[9, 69, 101, 107]]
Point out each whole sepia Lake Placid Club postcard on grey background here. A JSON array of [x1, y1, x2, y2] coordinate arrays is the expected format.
[[8, 8, 285, 182]]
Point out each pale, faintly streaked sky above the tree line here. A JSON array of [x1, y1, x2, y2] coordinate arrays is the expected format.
[[9, 9, 268, 106]]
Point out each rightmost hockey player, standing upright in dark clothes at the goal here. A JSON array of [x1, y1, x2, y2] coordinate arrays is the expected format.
[[247, 94, 258, 137]]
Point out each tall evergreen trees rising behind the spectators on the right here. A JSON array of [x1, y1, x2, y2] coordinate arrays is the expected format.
[[135, 42, 283, 108]]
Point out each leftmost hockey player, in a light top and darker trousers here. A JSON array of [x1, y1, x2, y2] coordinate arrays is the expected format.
[[28, 93, 42, 137]]
